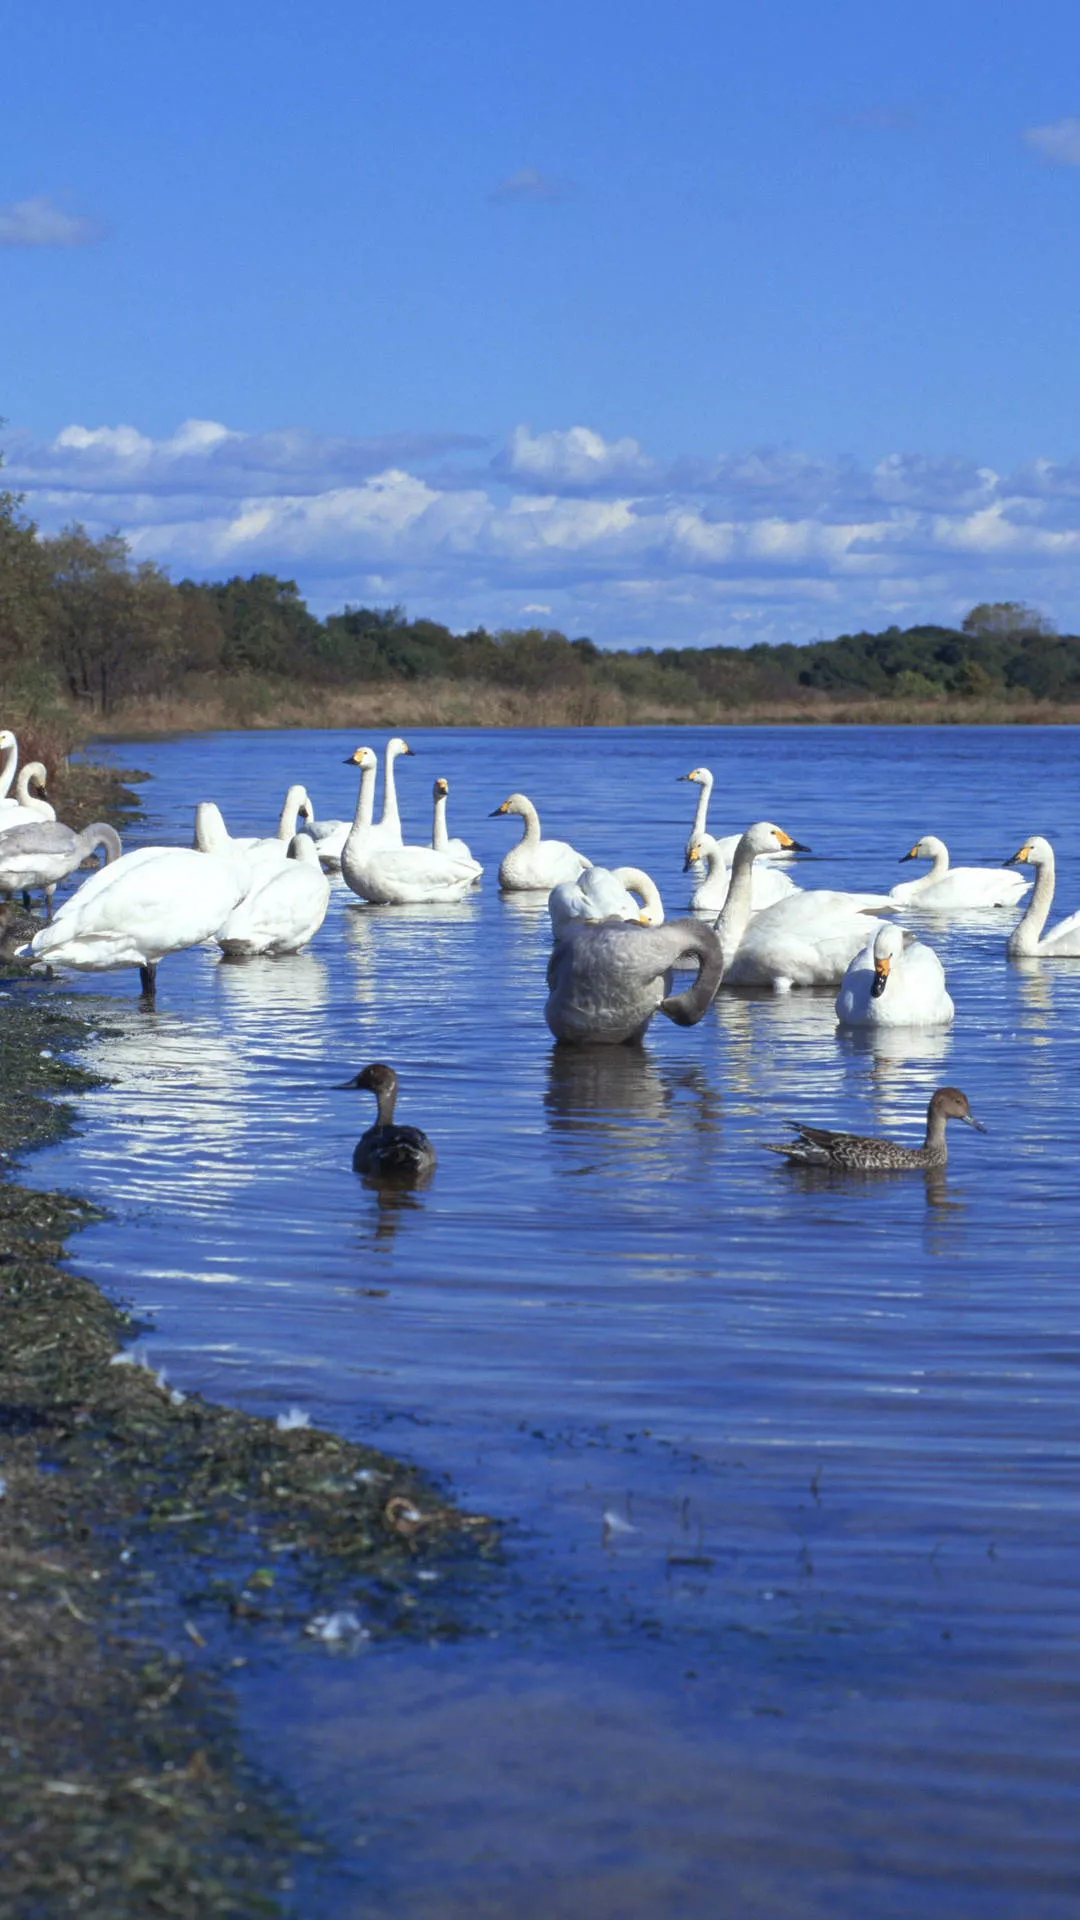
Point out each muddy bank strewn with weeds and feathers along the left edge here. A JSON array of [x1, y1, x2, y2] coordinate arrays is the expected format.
[[0, 977, 494, 1920]]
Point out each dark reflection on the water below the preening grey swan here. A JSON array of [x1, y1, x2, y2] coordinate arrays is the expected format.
[[544, 1046, 721, 1154]]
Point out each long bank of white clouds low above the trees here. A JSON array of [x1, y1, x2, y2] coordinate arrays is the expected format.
[[4, 420, 1080, 645]]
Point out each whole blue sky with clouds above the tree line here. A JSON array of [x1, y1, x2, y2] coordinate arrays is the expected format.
[[0, 0, 1080, 645]]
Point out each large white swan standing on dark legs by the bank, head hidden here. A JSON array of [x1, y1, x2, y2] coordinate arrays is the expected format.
[[19, 847, 246, 1000]]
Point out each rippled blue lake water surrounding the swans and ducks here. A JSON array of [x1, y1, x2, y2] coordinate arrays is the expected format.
[[31, 728, 1080, 1920]]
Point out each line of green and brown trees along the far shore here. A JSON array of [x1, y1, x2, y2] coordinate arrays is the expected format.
[[0, 464, 1080, 720]]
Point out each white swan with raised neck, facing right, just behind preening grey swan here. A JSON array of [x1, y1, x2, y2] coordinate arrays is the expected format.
[[717, 820, 888, 993]]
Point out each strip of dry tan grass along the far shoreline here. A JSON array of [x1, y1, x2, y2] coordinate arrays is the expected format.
[[88, 678, 1080, 739]]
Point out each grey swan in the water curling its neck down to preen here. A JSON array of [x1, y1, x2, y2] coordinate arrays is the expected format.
[[544, 920, 724, 1046]]
